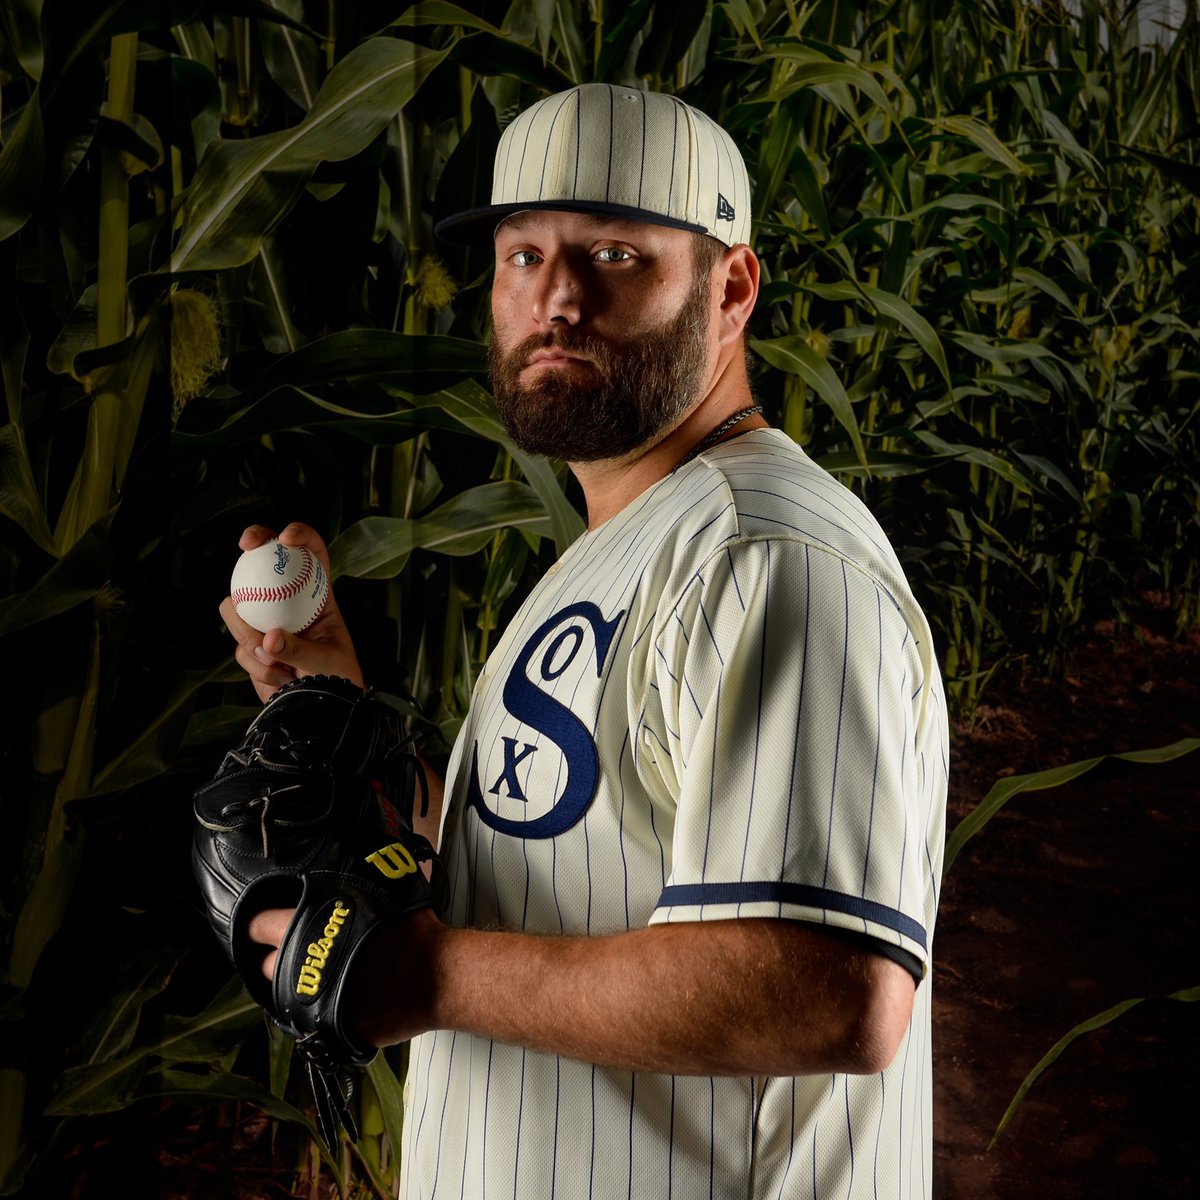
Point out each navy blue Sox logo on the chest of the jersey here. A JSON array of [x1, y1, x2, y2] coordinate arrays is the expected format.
[[467, 601, 625, 840]]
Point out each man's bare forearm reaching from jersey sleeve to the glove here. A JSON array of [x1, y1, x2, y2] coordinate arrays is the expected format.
[[350, 918, 913, 1075]]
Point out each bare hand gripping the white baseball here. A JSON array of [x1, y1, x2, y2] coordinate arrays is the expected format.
[[221, 523, 365, 703]]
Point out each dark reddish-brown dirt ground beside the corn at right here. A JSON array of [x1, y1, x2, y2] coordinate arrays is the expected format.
[[934, 626, 1200, 1200]]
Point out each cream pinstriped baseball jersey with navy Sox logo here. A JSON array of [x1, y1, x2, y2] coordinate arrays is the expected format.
[[402, 430, 947, 1200]]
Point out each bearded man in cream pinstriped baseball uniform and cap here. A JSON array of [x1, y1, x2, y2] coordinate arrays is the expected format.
[[222, 84, 947, 1200]]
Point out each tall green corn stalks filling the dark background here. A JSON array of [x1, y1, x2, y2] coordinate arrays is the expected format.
[[0, 0, 1200, 1196]]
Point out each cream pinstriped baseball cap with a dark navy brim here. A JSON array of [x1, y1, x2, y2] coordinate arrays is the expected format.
[[436, 83, 750, 246]]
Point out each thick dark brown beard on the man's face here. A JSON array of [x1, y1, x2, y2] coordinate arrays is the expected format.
[[488, 274, 712, 462]]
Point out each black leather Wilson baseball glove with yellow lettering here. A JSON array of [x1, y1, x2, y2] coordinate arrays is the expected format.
[[192, 676, 442, 1146]]
